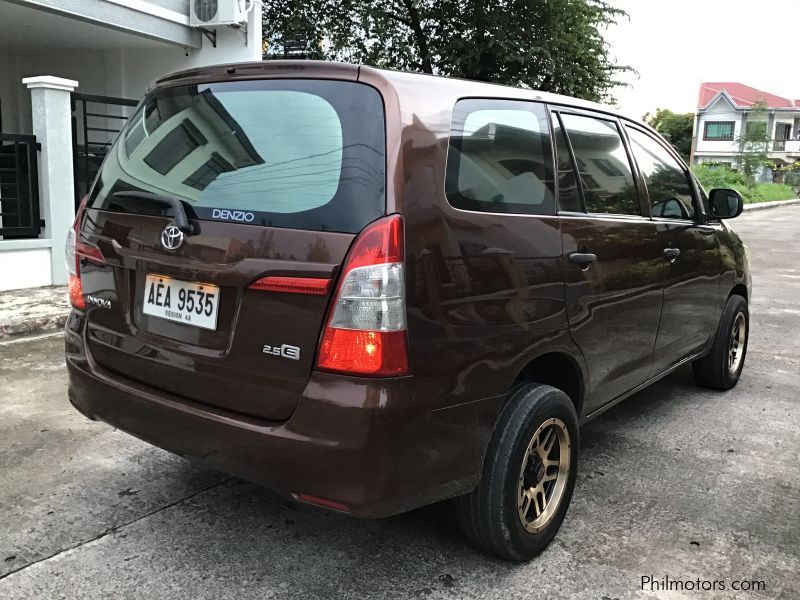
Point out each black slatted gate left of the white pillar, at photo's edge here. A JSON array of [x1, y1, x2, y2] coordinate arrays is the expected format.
[[0, 133, 44, 240]]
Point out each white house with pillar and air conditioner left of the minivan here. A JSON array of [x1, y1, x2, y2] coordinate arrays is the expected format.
[[0, 0, 262, 290]]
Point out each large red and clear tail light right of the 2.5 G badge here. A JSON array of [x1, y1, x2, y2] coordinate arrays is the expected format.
[[317, 215, 408, 377]]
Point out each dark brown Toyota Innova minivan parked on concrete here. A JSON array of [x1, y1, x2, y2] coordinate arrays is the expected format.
[[66, 61, 750, 560]]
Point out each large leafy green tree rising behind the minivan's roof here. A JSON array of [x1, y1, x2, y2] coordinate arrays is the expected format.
[[264, 0, 630, 100]]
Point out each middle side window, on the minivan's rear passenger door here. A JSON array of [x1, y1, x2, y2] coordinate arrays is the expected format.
[[561, 113, 641, 215]]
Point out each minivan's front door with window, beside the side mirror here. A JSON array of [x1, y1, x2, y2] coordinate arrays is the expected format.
[[625, 125, 722, 372]]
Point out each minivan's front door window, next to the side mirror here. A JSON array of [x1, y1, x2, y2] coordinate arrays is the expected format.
[[626, 127, 694, 219]]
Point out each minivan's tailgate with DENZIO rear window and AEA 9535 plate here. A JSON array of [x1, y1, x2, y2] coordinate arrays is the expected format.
[[81, 79, 385, 420]]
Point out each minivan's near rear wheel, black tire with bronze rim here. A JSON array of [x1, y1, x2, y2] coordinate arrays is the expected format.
[[455, 383, 579, 561]]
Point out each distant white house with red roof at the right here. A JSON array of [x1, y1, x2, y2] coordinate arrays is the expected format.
[[692, 82, 800, 181]]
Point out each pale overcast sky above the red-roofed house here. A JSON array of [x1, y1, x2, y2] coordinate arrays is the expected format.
[[605, 0, 800, 118]]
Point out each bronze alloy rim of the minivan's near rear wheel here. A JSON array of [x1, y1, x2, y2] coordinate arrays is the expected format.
[[517, 418, 570, 533]]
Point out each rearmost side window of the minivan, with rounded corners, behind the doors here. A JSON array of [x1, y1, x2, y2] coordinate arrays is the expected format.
[[445, 100, 555, 215]]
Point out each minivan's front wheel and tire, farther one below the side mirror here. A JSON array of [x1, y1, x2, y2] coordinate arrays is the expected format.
[[692, 296, 750, 390]]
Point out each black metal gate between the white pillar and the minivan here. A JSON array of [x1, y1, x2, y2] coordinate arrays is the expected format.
[[72, 92, 137, 207]]
